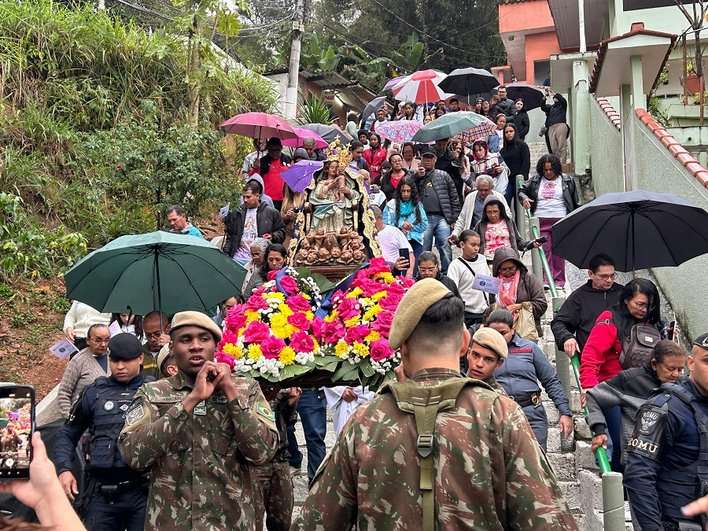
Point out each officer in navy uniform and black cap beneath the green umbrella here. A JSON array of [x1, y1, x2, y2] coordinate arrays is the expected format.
[[55, 334, 148, 531]]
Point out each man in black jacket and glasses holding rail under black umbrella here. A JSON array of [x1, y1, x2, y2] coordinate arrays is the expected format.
[[551, 254, 623, 357]]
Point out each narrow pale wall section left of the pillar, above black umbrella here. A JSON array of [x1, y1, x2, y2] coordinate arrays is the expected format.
[[590, 97, 623, 196]]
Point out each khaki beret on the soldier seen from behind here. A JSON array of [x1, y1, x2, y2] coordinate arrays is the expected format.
[[388, 278, 452, 348]]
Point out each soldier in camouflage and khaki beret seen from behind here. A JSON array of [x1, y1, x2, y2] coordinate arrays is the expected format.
[[293, 279, 577, 531]]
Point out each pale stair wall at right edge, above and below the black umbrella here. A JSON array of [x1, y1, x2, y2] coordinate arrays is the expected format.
[[629, 113, 708, 337]]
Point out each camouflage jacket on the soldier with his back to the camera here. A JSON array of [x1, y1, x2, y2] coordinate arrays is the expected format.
[[292, 369, 577, 531]]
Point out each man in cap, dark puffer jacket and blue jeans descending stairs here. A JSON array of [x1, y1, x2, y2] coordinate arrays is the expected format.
[[416, 149, 460, 274]]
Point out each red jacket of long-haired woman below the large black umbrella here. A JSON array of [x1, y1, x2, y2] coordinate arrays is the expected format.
[[580, 310, 622, 389]]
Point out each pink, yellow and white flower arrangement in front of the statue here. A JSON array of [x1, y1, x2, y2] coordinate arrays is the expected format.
[[216, 258, 413, 387]]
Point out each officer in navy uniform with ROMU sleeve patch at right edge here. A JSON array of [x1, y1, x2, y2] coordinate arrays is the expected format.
[[624, 333, 708, 531]]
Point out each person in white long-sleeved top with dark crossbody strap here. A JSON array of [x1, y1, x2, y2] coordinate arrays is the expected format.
[[447, 229, 492, 328]]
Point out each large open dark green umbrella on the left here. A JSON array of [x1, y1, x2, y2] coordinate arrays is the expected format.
[[64, 231, 246, 315]]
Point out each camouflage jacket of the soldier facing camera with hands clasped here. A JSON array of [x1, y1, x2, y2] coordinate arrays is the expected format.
[[119, 372, 278, 531]]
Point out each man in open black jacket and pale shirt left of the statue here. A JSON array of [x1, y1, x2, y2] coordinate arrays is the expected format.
[[224, 181, 285, 265]]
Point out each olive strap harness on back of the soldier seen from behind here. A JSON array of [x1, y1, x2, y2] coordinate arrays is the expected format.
[[379, 378, 491, 531]]
